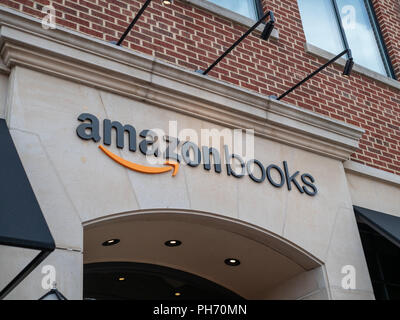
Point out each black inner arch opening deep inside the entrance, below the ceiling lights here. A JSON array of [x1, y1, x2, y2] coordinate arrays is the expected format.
[[83, 262, 243, 300]]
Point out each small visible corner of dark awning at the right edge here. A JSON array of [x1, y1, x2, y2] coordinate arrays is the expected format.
[[354, 206, 400, 247]]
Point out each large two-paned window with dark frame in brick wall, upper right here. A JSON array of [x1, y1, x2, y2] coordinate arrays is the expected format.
[[298, 0, 391, 76]]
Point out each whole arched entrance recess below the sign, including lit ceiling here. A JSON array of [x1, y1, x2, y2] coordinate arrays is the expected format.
[[84, 209, 326, 300]]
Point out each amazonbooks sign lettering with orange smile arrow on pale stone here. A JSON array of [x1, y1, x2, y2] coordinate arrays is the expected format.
[[76, 113, 318, 196]]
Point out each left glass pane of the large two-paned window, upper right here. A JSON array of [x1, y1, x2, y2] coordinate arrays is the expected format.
[[298, 0, 344, 53]]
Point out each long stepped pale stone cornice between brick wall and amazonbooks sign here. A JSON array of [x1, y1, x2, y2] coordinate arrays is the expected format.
[[0, 8, 364, 160]]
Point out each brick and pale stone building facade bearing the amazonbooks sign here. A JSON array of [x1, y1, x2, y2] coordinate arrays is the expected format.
[[0, 0, 400, 300]]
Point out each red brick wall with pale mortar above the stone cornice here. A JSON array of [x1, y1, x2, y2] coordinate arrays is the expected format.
[[0, 0, 400, 174]]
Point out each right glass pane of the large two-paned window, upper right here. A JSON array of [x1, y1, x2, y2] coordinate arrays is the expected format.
[[338, 0, 387, 75]]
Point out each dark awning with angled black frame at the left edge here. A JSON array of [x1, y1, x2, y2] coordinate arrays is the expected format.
[[0, 119, 55, 299]]
